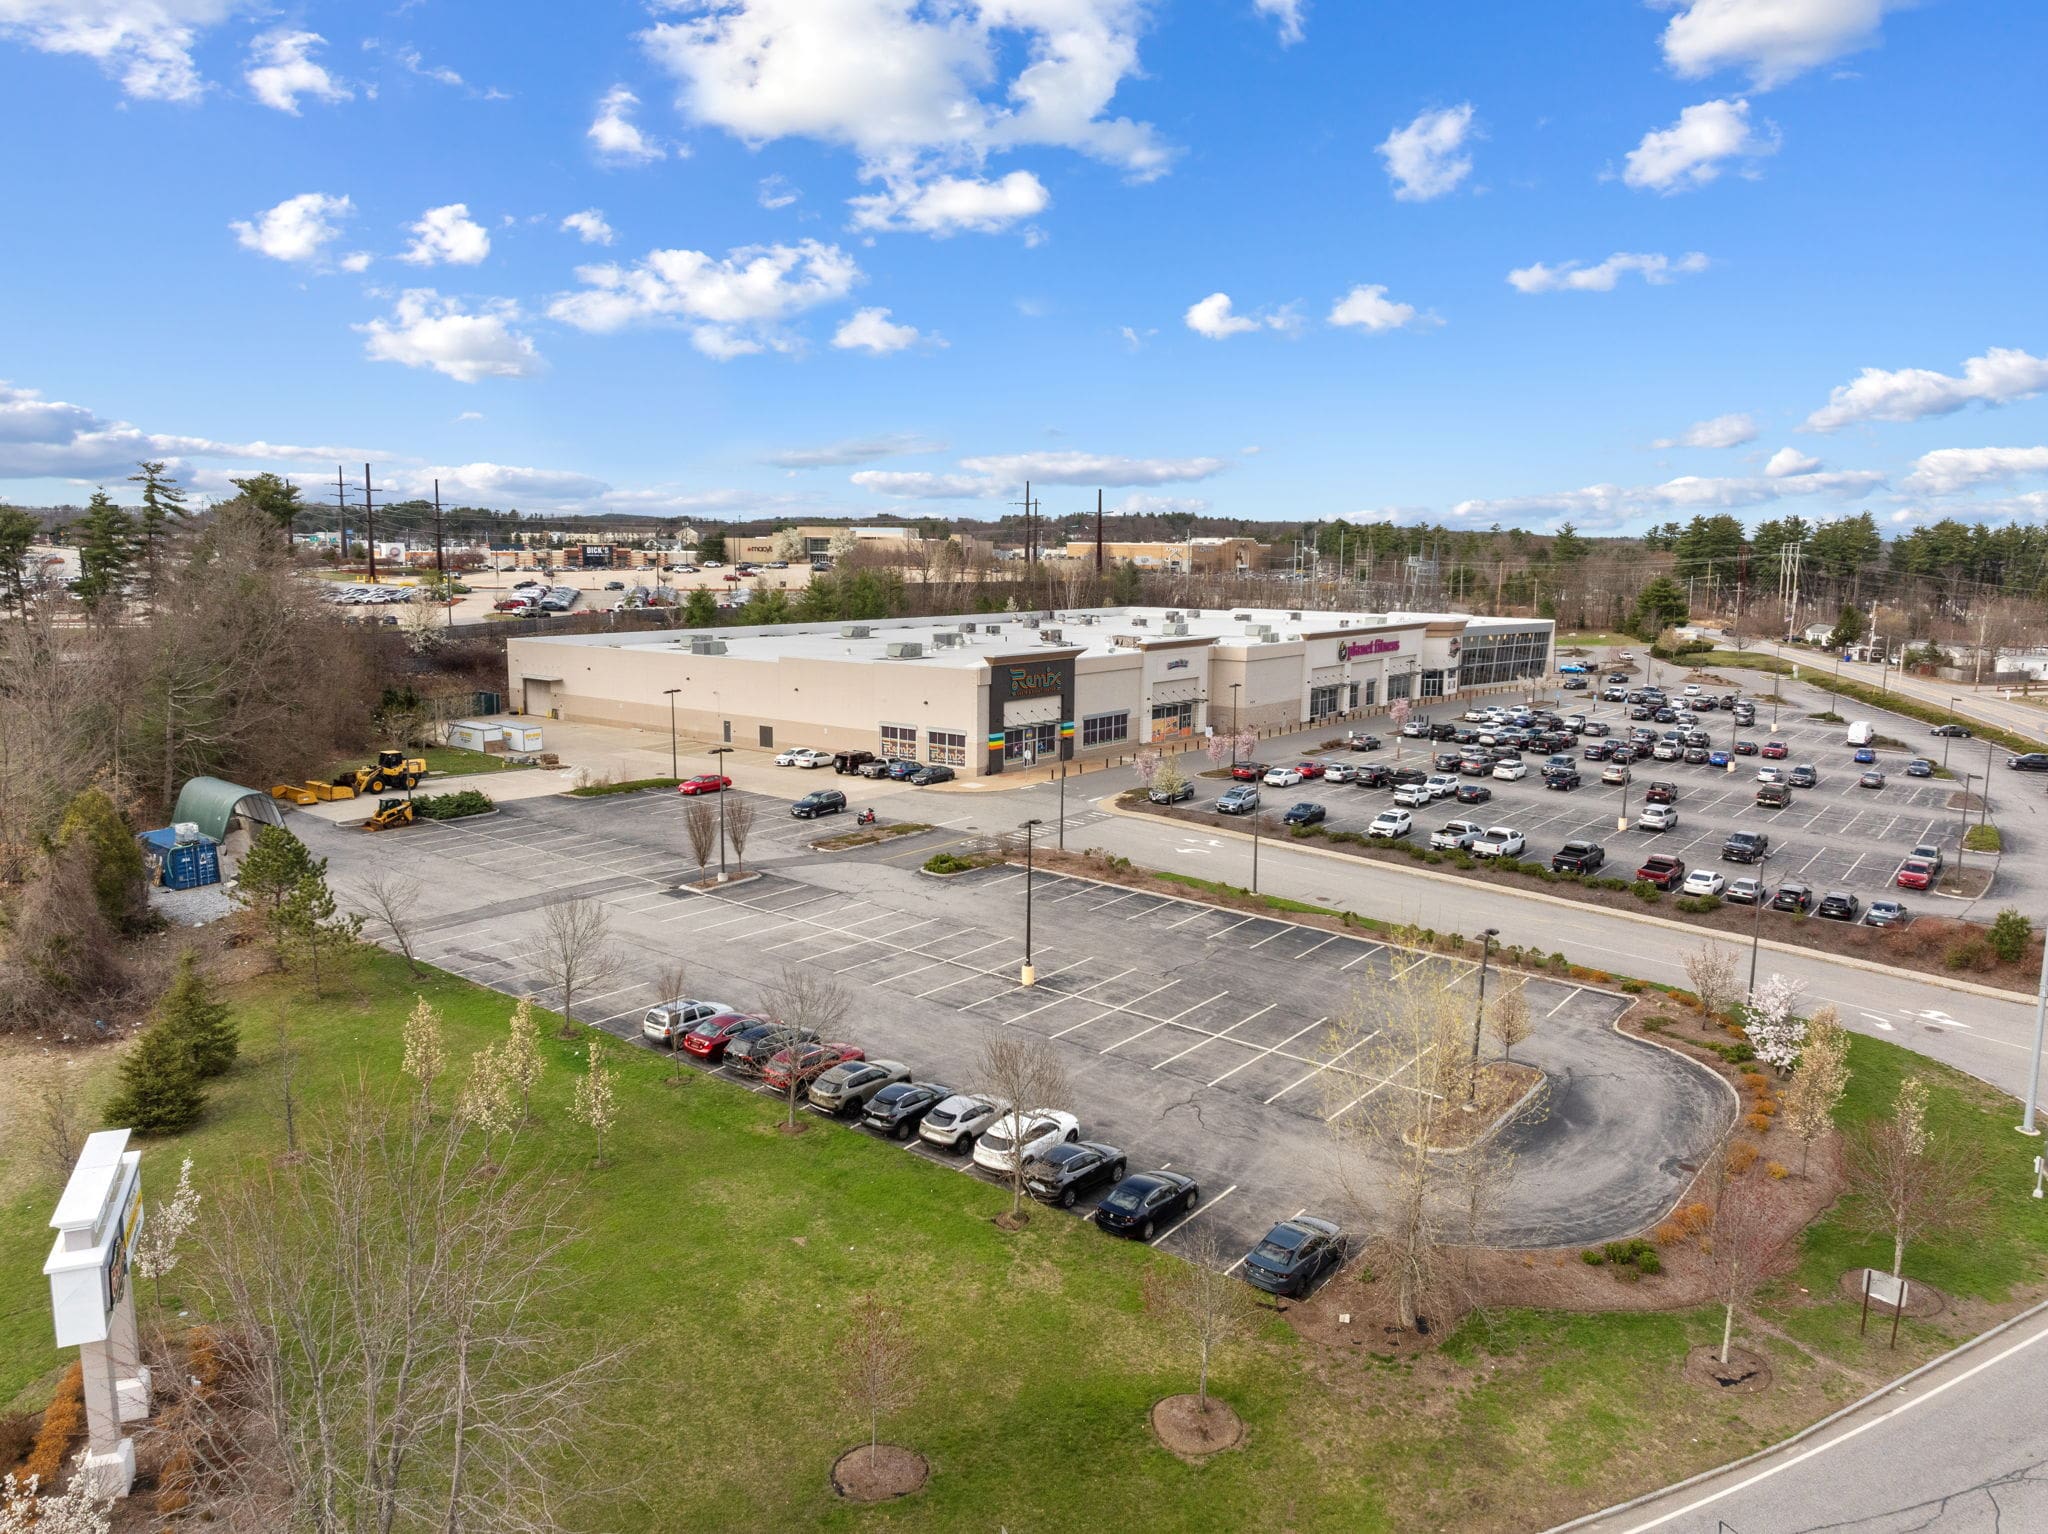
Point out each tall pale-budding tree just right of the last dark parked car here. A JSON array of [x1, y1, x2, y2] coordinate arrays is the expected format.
[[1319, 967, 1513, 1329]]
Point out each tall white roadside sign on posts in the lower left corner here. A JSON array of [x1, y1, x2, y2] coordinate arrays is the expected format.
[[43, 1128, 150, 1497]]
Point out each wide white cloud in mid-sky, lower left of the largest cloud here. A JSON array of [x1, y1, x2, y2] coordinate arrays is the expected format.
[[547, 240, 860, 360]]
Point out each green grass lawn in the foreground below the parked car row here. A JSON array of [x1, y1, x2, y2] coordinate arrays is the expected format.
[[0, 954, 2048, 1534]]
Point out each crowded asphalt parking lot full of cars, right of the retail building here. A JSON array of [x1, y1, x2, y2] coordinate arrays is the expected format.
[[1212, 688, 2015, 909]]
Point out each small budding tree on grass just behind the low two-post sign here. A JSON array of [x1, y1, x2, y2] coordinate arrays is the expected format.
[[1847, 1075, 1987, 1278]]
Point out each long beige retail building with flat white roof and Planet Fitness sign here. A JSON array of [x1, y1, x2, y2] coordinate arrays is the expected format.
[[508, 608, 1554, 776]]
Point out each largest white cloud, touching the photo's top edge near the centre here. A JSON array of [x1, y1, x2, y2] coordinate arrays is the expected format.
[[641, 0, 1171, 178]]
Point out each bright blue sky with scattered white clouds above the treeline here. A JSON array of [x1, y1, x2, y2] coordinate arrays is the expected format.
[[0, 0, 2048, 530]]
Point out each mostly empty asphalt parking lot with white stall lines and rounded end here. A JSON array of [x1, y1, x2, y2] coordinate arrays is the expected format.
[[309, 793, 1729, 1251]]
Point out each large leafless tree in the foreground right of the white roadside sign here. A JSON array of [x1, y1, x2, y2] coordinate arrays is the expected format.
[[195, 1094, 618, 1534]]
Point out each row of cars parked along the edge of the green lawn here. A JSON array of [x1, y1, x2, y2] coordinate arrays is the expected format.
[[641, 997, 1346, 1294]]
